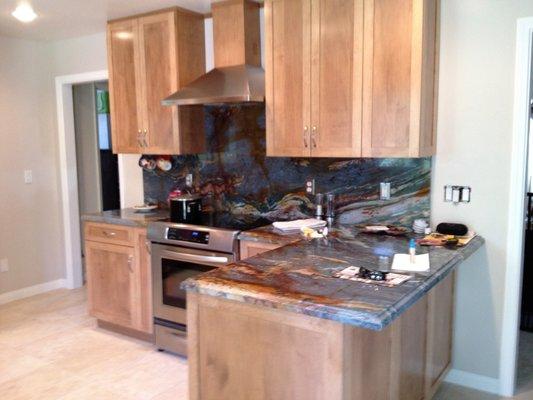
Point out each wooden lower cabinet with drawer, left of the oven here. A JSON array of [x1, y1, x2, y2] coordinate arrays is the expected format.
[[85, 223, 153, 335]]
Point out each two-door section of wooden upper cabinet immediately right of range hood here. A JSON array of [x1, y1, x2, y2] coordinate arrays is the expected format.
[[265, 0, 363, 157]]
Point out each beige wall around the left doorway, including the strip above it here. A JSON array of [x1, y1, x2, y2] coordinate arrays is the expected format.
[[0, 33, 142, 295]]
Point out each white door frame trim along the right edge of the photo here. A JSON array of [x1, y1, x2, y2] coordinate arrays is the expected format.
[[500, 17, 533, 396]]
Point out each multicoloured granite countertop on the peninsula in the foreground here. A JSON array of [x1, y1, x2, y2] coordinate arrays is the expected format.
[[182, 227, 484, 330]]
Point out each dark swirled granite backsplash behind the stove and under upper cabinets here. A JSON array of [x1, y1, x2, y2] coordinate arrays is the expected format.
[[144, 105, 431, 226]]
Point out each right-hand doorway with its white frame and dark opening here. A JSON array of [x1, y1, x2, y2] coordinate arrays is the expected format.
[[500, 17, 533, 398]]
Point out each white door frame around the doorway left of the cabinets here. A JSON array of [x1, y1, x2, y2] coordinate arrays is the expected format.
[[55, 70, 142, 289]]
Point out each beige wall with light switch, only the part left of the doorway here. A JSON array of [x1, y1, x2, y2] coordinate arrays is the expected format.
[[0, 37, 64, 293]]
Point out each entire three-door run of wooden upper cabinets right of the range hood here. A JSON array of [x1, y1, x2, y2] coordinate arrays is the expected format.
[[265, 0, 437, 157]]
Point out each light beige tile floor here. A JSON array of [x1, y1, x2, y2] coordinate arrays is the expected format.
[[0, 290, 533, 400]]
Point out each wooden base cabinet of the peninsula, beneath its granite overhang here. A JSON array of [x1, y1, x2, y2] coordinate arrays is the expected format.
[[187, 275, 453, 400]]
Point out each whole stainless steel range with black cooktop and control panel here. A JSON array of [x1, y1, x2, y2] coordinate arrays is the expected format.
[[148, 213, 269, 355]]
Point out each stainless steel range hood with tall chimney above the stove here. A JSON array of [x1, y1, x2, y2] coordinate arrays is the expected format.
[[162, 0, 265, 106]]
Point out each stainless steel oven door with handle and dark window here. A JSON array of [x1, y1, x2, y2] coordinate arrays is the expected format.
[[152, 243, 234, 325]]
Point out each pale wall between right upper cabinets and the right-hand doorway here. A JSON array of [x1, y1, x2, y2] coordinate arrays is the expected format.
[[432, 0, 533, 386]]
